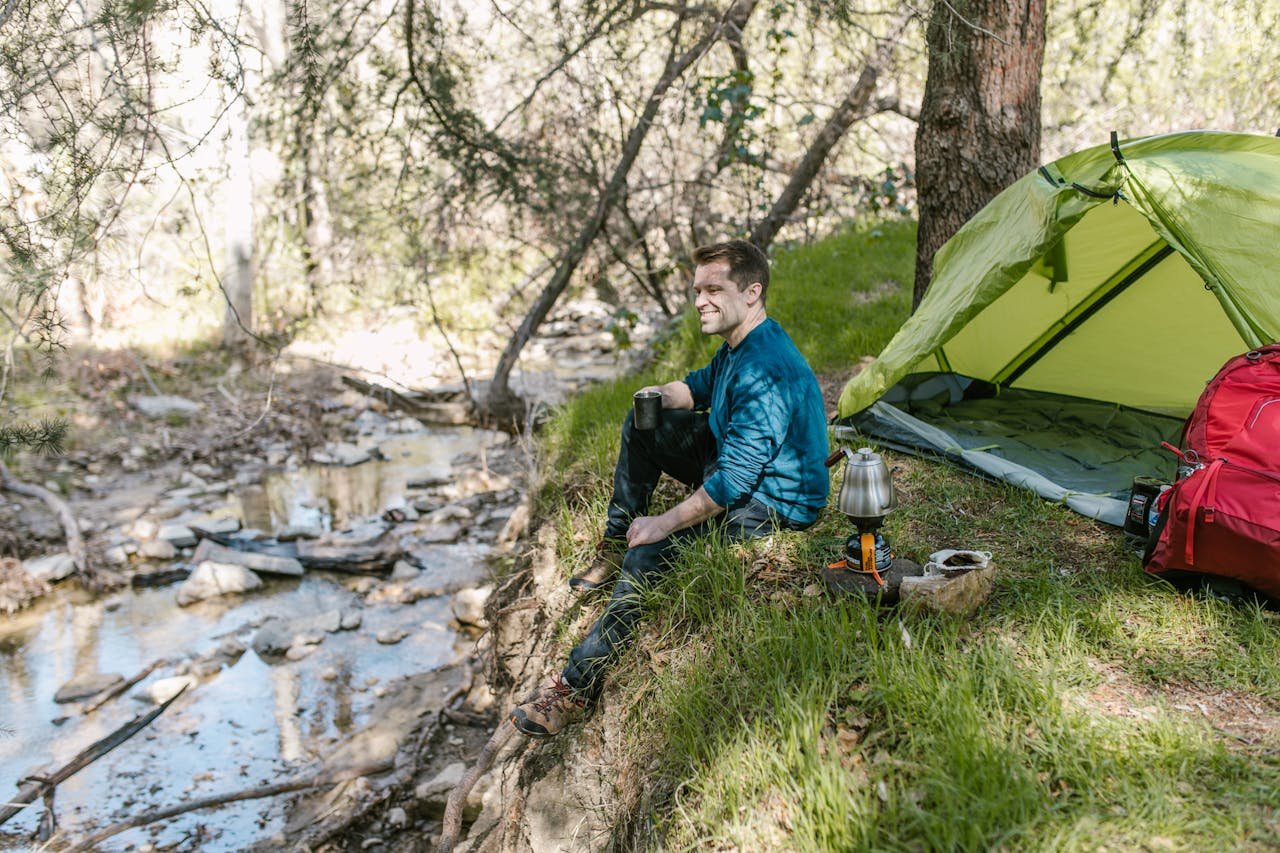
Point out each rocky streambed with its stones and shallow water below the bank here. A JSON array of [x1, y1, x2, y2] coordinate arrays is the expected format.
[[0, 394, 527, 850]]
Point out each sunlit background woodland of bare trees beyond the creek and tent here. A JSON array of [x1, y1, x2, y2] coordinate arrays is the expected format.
[[0, 0, 1280, 424]]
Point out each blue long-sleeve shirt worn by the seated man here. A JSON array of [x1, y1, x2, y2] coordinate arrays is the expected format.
[[685, 319, 829, 524]]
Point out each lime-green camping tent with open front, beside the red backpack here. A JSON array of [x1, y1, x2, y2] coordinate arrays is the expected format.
[[840, 132, 1280, 525]]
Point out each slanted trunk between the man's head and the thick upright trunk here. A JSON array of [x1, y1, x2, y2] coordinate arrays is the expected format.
[[750, 15, 908, 248]]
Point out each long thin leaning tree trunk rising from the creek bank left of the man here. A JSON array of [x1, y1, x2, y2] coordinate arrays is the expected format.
[[483, 0, 756, 423]]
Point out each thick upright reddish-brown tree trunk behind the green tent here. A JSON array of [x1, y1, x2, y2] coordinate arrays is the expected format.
[[913, 0, 1044, 305]]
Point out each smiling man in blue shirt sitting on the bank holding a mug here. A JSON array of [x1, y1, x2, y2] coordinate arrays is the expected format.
[[511, 240, 828, 738]]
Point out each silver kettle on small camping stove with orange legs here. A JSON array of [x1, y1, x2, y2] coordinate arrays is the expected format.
[[823, 447, 897, 590]]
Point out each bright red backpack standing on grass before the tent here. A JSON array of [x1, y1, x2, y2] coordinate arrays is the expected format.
[[1143, 343, 1280, 599]]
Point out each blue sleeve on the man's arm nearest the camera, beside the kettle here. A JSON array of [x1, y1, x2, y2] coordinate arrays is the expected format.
[[703, 363, 791, 507]]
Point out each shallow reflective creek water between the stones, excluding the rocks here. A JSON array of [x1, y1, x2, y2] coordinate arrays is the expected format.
[[0, 428, 516, 850]]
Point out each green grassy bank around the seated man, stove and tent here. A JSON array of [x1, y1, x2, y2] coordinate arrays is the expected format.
[[529, 223, 1280, 850]]
